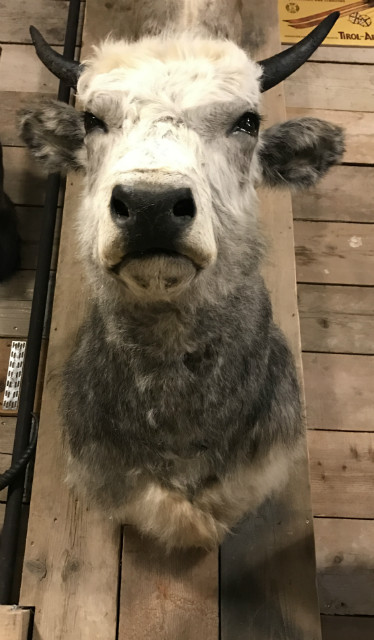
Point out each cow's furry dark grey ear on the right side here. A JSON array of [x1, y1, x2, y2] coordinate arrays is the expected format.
[[259, 118, 344, 188]]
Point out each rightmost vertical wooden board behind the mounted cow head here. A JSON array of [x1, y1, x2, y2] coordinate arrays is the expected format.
[[221, 1, 321, 640]]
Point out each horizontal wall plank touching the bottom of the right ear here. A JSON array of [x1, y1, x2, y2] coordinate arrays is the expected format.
[[292, 165, 374, 222]]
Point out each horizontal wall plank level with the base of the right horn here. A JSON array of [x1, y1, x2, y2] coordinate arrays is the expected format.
[[284, 62, 374, 112]]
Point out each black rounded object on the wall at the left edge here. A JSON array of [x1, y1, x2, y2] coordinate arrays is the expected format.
[[0, 143, 20, 282]]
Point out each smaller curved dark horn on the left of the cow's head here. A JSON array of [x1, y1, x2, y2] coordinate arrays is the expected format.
[[30, 27, 83, 87]]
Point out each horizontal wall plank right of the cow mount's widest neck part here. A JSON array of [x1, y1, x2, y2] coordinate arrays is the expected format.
[[303, 353, 374, 431]]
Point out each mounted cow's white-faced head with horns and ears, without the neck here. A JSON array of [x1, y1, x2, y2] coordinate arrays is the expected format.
[[21, 14, 343, 302]]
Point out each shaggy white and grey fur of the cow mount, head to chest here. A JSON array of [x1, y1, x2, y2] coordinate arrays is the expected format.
[[21, 33, 343, 548]]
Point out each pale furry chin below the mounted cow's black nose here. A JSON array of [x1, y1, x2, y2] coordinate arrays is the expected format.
[[117, 253, 198, 300]]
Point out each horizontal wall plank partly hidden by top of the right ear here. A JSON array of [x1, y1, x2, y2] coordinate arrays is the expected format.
[[287, 105, 374, 166]]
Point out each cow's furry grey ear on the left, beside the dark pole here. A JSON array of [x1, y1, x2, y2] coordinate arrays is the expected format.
[[18, 101, 85, 172]]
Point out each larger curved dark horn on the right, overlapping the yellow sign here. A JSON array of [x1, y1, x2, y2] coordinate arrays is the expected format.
[[258, 11, 340, 92]]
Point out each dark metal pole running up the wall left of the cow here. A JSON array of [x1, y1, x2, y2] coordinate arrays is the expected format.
[[0, 0, 80, 604]]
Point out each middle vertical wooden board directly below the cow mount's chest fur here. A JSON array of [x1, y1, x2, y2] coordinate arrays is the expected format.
[[118, 527, 218, 640]]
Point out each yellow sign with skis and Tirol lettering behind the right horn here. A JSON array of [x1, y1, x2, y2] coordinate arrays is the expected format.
[[278, 0, 374, 47]]
